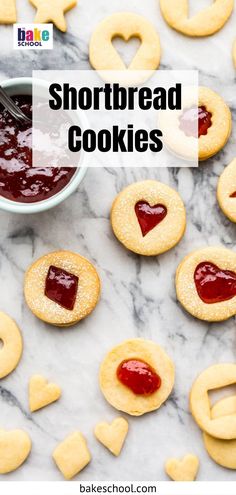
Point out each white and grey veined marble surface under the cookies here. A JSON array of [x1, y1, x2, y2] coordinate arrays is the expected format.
[[0, 0, 236, 481]]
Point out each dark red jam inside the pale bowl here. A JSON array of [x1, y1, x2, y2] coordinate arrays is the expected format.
[[0, 95, 75, 203]]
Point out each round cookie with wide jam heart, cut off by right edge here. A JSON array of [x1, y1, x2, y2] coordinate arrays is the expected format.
[[176, 247, 236, 321]]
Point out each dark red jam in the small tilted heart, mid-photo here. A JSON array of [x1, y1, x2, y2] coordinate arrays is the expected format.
[[135, 201, 167, 237]]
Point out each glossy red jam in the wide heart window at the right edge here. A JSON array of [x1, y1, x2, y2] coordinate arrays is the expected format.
[[194, 261, 236, 304]]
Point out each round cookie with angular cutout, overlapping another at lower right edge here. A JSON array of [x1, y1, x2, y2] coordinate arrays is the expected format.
[[190, 363, 236, 440]]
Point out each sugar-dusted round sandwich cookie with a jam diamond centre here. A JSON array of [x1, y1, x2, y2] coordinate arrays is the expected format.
[[24, 251, 100, 327]]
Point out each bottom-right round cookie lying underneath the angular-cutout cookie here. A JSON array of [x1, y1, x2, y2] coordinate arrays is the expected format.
[[203, 395, 236, 469]]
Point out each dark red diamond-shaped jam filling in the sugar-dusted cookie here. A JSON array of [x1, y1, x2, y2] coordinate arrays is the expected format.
[[45, 265, 79, 311]]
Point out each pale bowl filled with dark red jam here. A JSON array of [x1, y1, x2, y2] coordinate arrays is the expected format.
[[0, 78, 87, 213]]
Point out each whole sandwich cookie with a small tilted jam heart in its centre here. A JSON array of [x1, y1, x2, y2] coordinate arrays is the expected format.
[[111, 180, 186, 256]]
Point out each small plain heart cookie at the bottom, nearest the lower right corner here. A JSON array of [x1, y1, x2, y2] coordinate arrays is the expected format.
[[165, 454, 199, 481]]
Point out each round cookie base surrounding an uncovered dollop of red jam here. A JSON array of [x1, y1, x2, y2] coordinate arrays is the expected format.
[[99, 339, 175, 416]]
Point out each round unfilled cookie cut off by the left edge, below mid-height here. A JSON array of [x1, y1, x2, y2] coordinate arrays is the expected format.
[[0, 312, 23, 378]]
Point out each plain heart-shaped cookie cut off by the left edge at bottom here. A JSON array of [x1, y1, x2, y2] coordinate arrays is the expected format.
[[0, 430, 31, 474]]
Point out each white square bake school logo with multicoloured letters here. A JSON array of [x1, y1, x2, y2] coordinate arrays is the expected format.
[[13, 24, 53, 50]]
